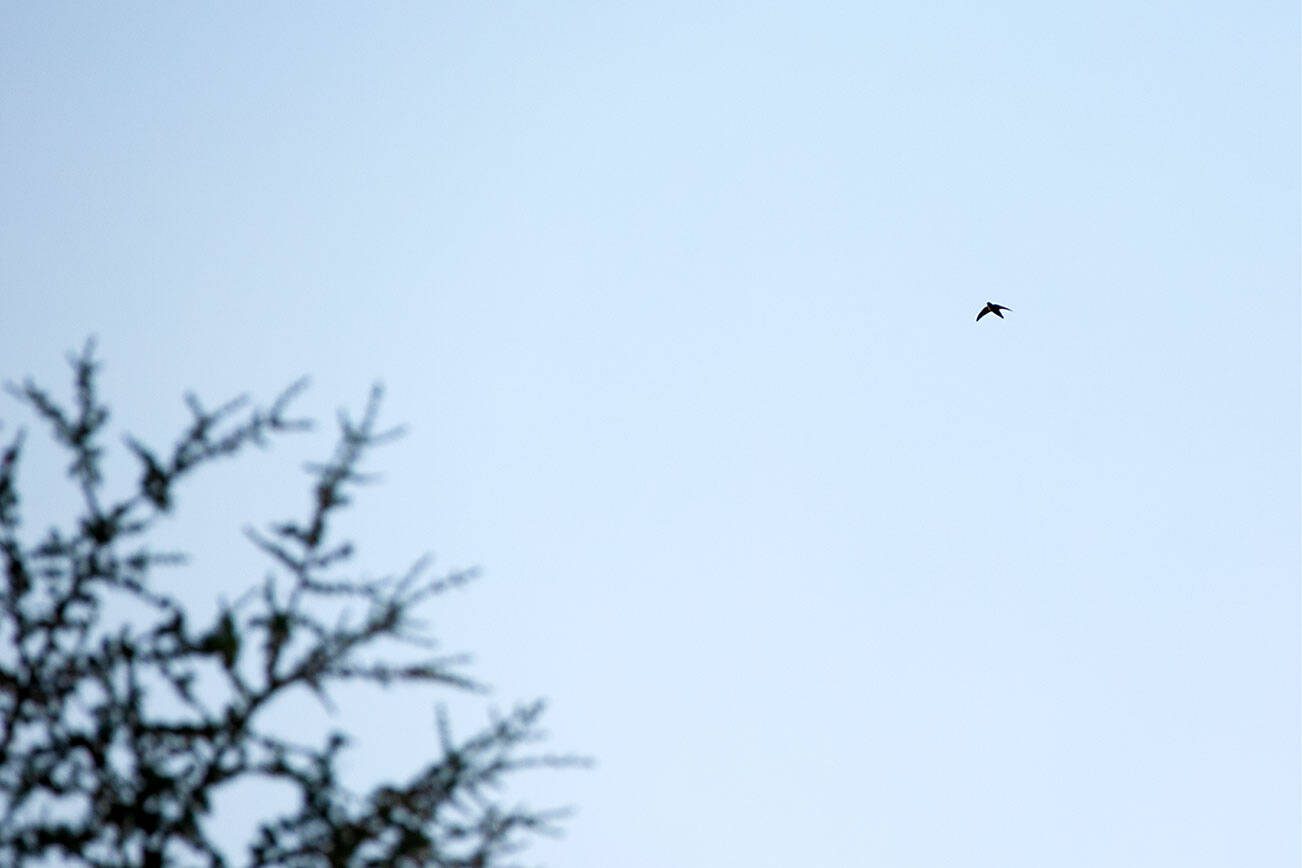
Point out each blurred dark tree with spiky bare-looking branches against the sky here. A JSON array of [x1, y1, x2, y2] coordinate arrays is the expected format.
[[0, 344, 579, 868]]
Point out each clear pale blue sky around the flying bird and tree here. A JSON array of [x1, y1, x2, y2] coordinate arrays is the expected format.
[[0, 0, 1302, 868]]
